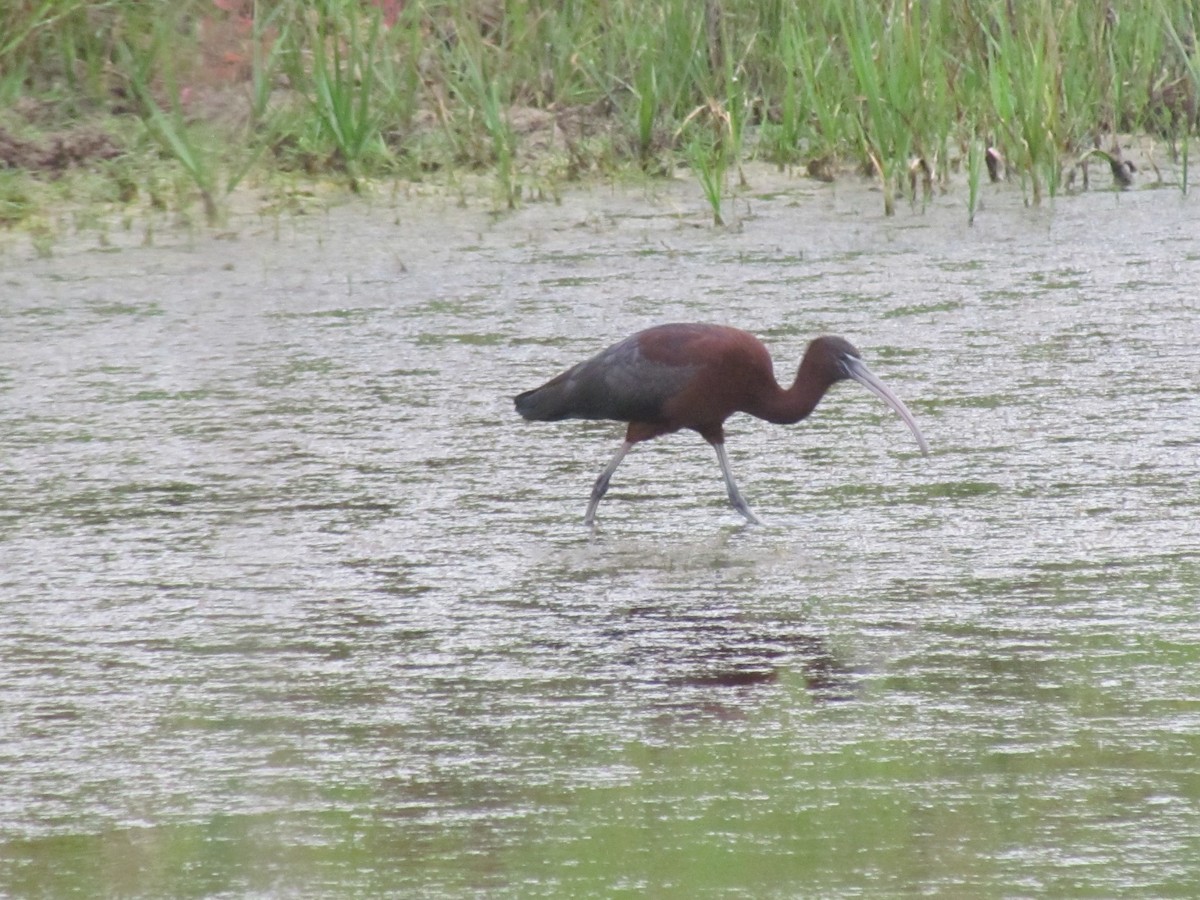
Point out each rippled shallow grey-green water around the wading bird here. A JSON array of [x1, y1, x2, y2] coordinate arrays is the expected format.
[[0, 172, 1200, 896]]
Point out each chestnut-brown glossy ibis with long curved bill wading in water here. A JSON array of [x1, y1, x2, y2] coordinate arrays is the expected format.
[[515, 325, 929, 526]]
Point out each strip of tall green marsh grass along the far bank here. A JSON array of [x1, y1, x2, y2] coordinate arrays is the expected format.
[[0, 0, 1200, 220]]
